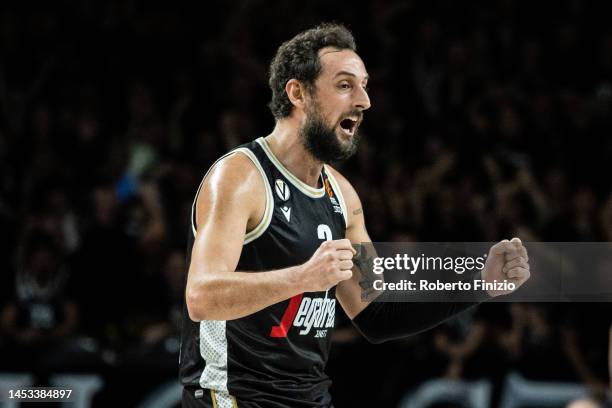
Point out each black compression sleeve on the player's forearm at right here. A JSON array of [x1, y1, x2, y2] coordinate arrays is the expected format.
[[353, 286, 491, 344]]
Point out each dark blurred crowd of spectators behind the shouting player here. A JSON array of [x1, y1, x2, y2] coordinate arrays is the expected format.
[[0, 0, 612, 406]]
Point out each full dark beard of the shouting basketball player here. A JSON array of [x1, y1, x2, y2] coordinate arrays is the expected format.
[[299, 101, 362, 163]]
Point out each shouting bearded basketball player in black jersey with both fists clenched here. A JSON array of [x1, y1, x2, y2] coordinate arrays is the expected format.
[[180, 24, 529, 408]]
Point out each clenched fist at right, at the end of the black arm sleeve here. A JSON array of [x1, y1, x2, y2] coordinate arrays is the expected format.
[[482, 238, 530, 296]]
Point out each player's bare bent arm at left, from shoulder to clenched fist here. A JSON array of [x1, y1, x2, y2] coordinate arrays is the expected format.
[[185, 153, 352, 321]]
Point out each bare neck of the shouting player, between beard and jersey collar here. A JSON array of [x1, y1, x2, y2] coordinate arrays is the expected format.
[[266, 118, 323, 188]]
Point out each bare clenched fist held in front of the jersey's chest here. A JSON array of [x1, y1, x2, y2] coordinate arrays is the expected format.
[[297, 239, 357, 292]]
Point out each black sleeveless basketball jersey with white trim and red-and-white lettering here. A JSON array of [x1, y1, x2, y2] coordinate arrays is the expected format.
[[180, 138, 346, 408]]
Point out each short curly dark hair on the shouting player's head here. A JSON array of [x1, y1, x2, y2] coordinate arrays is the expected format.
[[268, 23, 357, 120]]
